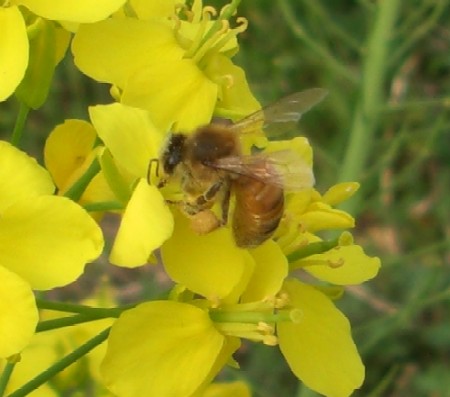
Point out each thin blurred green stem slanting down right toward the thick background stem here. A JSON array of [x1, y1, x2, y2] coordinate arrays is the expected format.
[[278, 0, 357, 84]]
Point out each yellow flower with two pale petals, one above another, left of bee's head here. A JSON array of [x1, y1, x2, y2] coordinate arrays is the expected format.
[[89, 103, 173, 267]]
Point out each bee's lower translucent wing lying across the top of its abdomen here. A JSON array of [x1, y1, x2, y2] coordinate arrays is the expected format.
[[207, 150, 314, 191]]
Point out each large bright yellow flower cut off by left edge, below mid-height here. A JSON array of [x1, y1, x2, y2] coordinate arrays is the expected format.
[[0, 141, 103, 355]]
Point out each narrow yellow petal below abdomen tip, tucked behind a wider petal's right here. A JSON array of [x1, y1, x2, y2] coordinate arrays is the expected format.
[[241, 240, 288, 302]]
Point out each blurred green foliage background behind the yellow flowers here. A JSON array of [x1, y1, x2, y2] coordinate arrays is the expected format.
[[0, 0, 450, 397]]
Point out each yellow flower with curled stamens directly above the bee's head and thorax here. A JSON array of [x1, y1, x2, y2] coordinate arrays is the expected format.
[[72, 0, 259, 131]]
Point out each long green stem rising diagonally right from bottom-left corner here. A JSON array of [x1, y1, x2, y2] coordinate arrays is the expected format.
[[8, 328, 111, 397]]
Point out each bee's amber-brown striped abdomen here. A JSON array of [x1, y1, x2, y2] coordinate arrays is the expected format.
[[233, 176, 284, 248]]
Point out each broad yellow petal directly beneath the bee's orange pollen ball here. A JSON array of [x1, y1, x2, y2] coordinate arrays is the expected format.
[[161, 213, 254, 301]]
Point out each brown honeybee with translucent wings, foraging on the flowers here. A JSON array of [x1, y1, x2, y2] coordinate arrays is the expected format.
[[160, 88, 327, 248]]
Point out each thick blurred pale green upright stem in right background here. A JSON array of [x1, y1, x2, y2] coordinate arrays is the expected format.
[[338, 0, 401, 215]]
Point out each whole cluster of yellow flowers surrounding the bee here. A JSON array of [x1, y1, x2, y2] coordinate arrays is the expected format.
[[0, 0, 380, 397]]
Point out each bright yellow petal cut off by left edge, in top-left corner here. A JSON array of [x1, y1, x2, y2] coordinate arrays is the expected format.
[[0, 7, 28, 101]]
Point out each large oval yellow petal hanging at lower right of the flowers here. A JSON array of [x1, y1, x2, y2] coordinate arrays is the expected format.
[[278, 280, 364, 397]]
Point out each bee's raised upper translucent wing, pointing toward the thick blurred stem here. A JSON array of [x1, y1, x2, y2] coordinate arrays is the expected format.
[[230, 88, 328, 137]]
